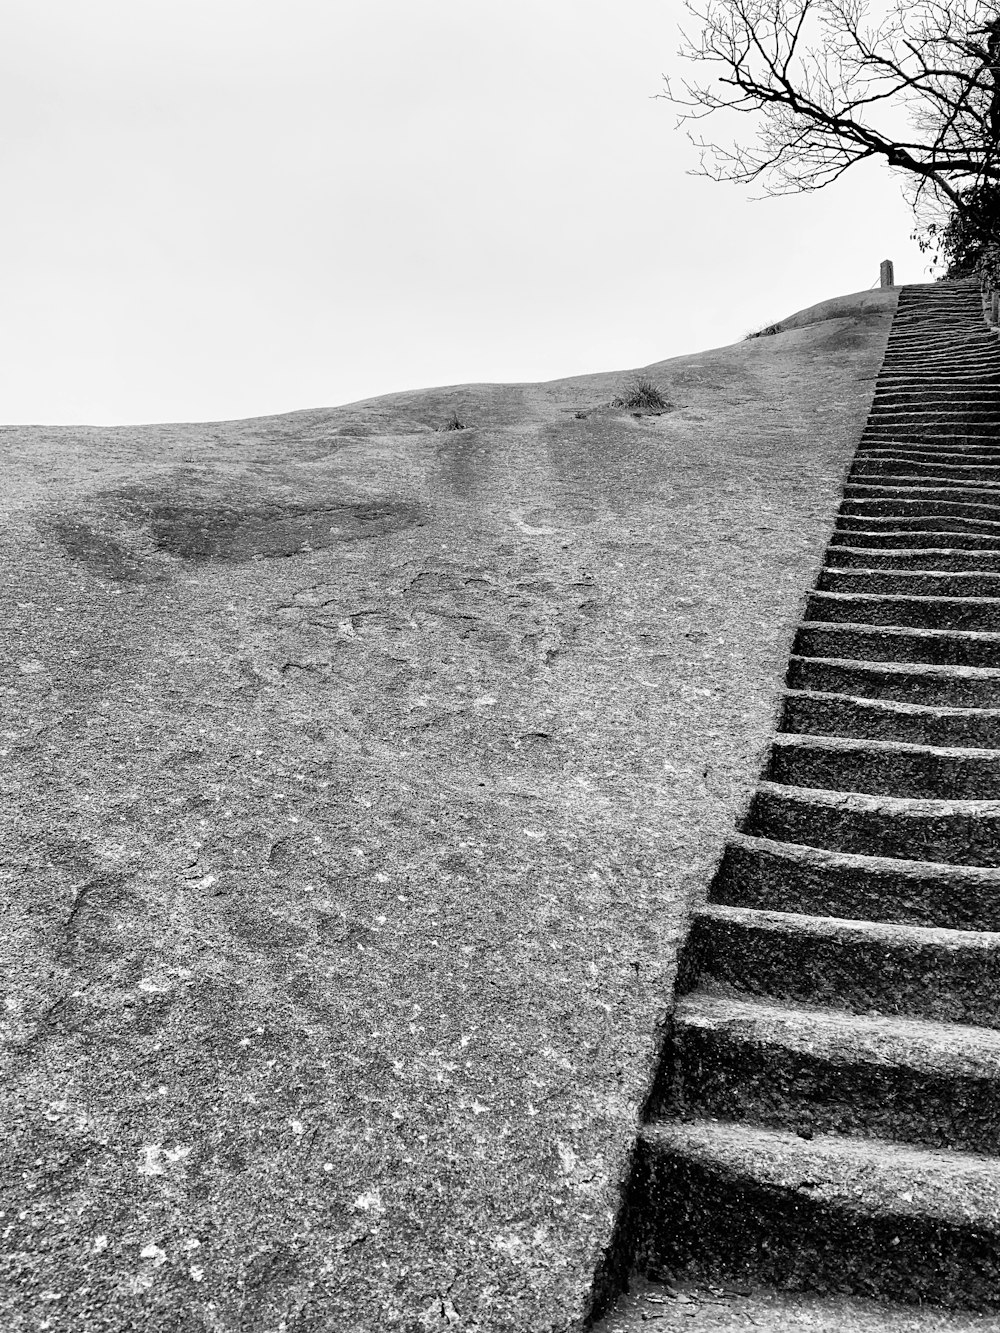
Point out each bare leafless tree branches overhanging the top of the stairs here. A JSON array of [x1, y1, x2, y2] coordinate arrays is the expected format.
[[665, 0, 1000, 240]]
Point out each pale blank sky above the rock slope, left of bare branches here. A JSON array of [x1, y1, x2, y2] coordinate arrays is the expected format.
[[0, 0, 928, 424]]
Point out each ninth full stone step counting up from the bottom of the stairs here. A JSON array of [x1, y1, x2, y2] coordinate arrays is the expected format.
[[792, 621, 1000, 666]]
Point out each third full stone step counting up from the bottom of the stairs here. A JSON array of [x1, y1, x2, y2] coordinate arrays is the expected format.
[[677, 904, 1000, 1029]]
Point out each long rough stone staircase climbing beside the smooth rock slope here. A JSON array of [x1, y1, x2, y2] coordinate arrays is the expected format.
[[610, 275, 1000, 1326]]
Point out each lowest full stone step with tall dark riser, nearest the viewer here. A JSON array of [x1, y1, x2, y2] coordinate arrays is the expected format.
[[632, 1121, 1000, 1310]]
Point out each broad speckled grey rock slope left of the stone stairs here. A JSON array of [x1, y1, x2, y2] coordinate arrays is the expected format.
[[0, 292, 896, 1333]]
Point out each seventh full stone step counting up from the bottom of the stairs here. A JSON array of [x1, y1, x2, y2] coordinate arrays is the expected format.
[[780, 689, 1000, 750]]
